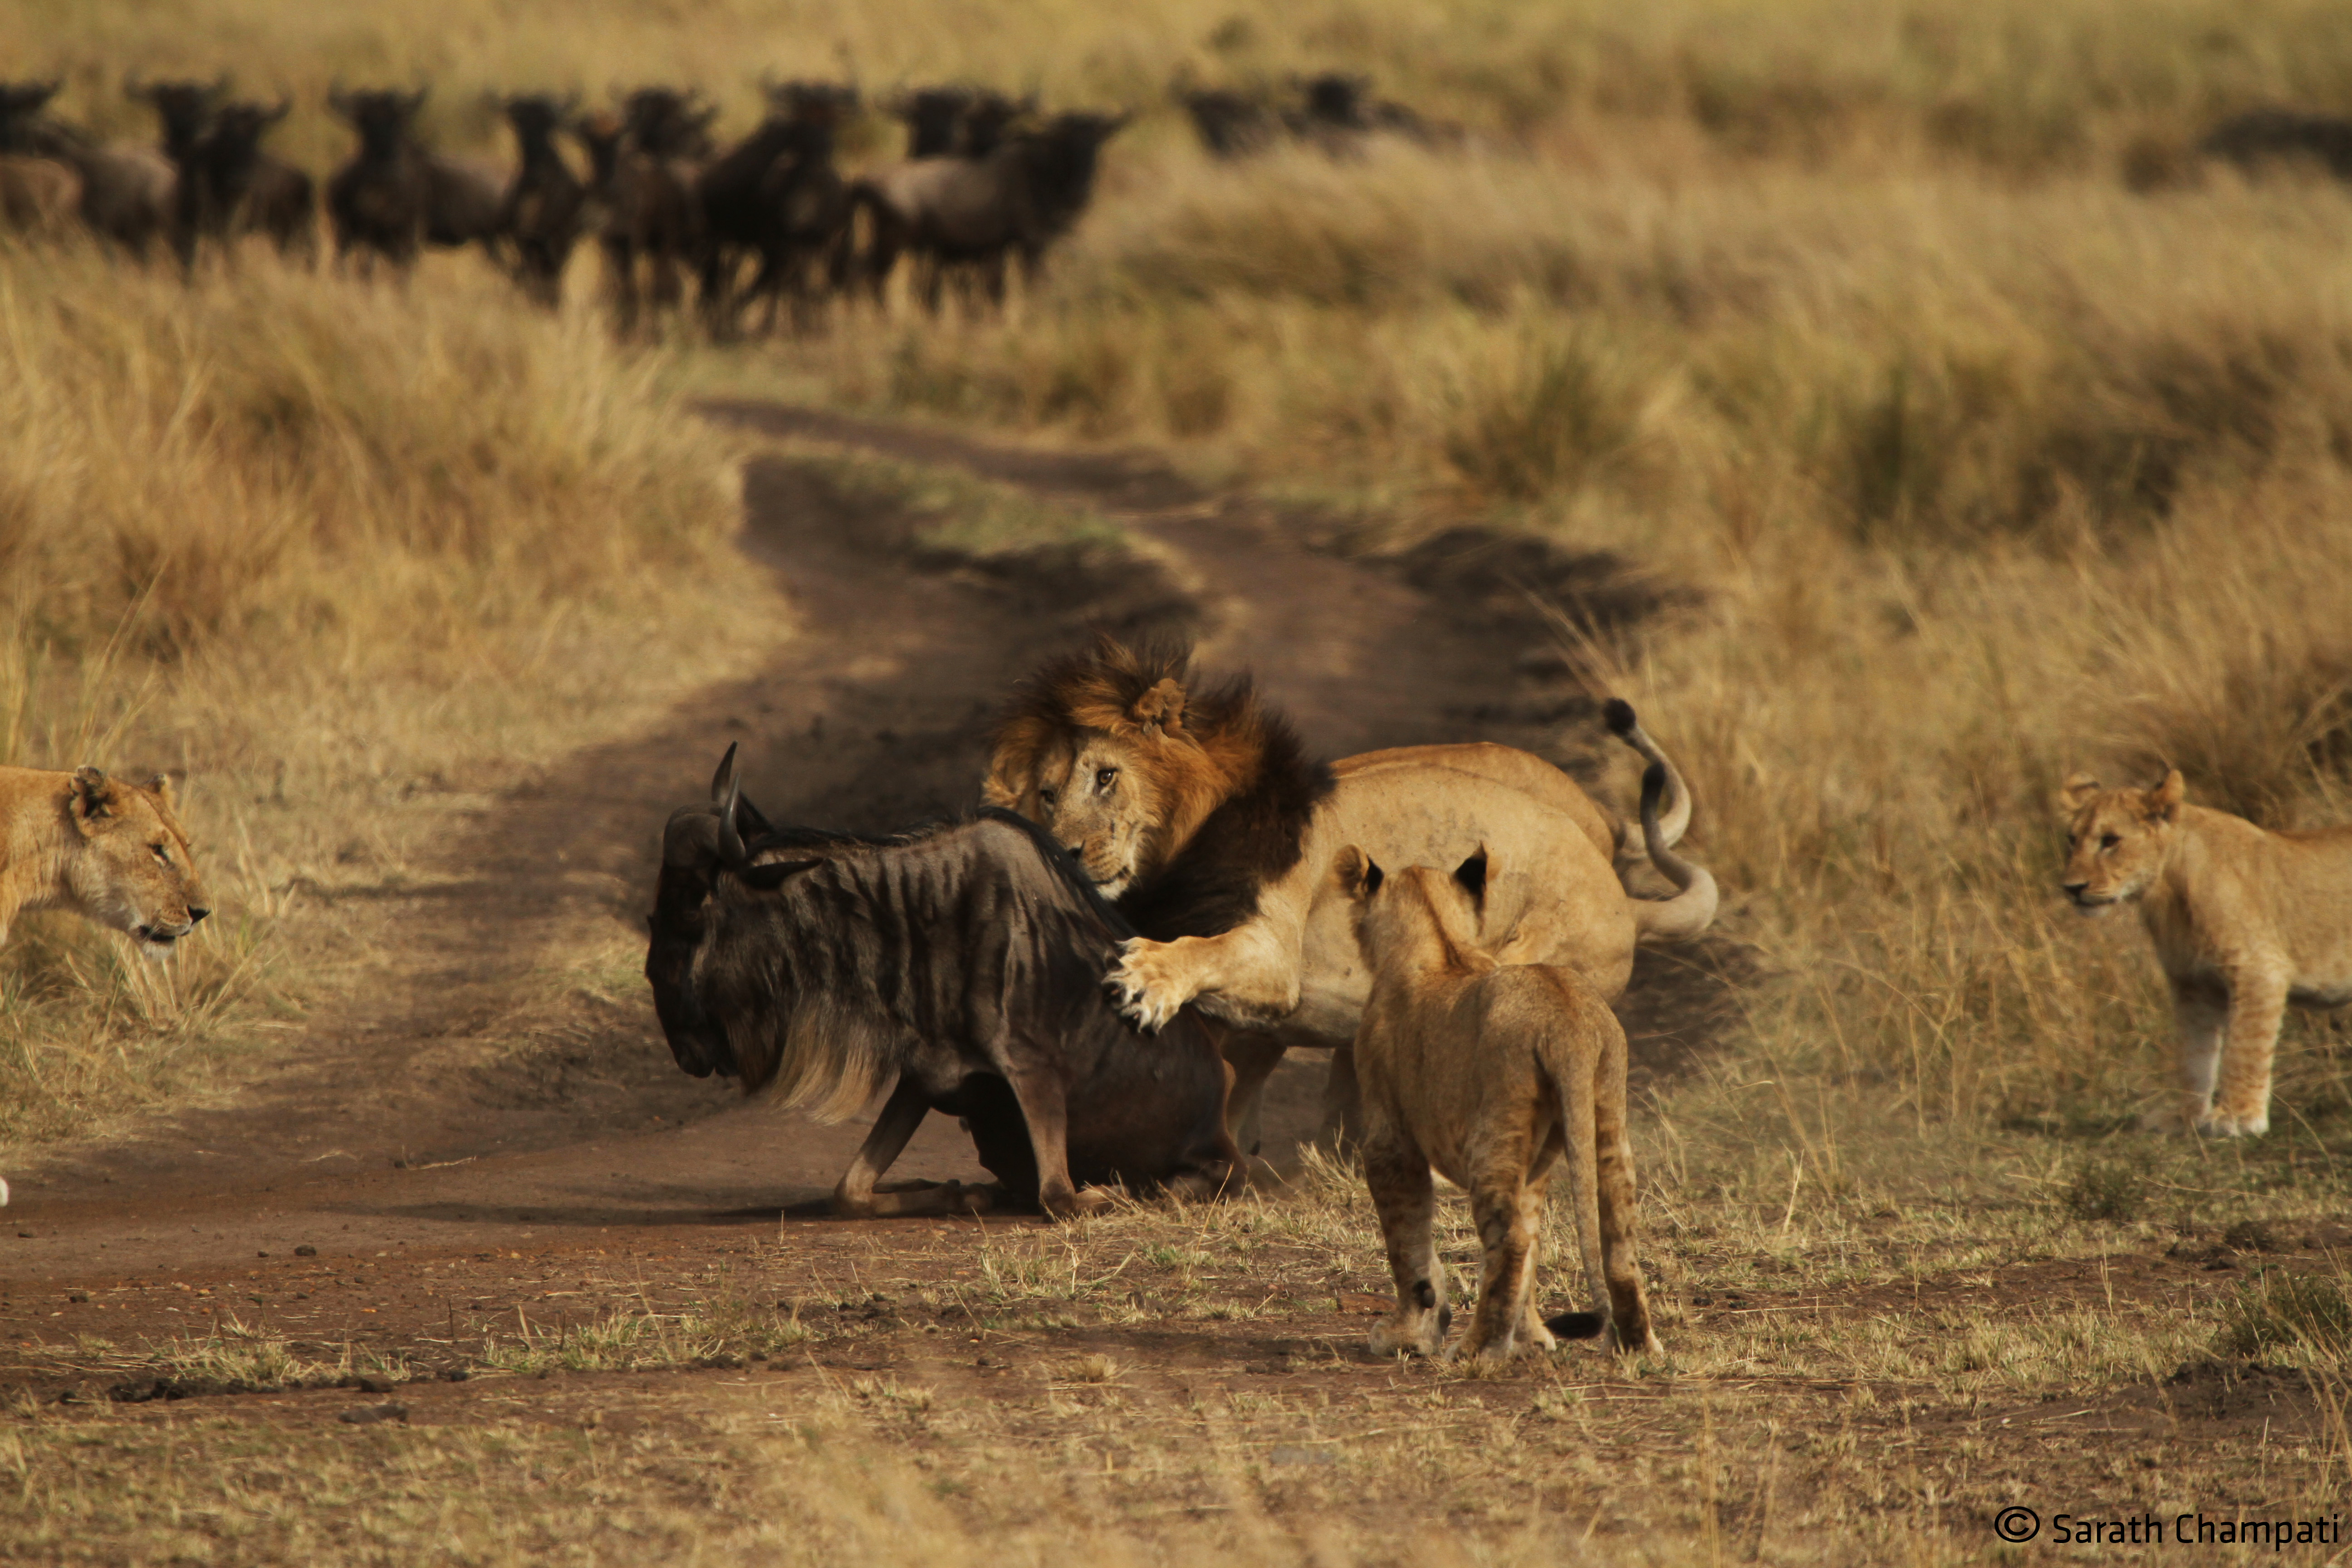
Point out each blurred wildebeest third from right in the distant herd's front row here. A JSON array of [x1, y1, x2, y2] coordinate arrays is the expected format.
[[578, 87, 717, 332]]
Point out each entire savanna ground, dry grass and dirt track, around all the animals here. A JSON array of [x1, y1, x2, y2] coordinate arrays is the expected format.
[[0, 0, 2352, 1563]]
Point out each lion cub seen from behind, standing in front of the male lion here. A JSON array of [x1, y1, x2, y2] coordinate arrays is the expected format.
[[1336, 846, 1658, 1357]]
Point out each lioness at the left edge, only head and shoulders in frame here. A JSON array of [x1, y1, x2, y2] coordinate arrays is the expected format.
[[0, 769, 212, 959]]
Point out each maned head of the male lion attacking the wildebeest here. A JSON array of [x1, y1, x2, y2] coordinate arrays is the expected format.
[[981, 637, 1263, 898]]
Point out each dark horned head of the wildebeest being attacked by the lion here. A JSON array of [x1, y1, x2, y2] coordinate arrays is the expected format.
[[644, 745, 811, 1079]]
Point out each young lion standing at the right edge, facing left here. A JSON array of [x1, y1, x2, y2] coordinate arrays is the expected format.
[[2058, 769, 2352, 1138]]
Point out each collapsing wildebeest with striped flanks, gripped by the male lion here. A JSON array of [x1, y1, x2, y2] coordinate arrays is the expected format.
[[644, 748, 1242, 1218]]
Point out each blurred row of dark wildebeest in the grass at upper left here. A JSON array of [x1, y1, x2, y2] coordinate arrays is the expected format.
[[0, 80, 1129, 332]]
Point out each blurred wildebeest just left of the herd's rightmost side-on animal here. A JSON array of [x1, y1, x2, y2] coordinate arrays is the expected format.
[[694, 82, 858, 336]]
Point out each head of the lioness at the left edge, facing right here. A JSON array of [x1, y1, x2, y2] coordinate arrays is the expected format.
[[66, 769, 212, 959]]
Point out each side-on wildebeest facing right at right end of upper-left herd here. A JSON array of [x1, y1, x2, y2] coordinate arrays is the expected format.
[[852, 113, 1127, 310]]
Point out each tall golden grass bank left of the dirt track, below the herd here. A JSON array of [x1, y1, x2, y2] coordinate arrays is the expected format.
[[0, 251, 774, 1140]]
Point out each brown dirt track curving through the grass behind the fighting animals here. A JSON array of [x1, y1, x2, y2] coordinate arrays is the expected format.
[[0, 404, 1720, 1382]]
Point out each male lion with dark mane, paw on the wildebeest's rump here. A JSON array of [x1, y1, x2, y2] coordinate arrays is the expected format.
[[983, 637, 1717, 1147]]
